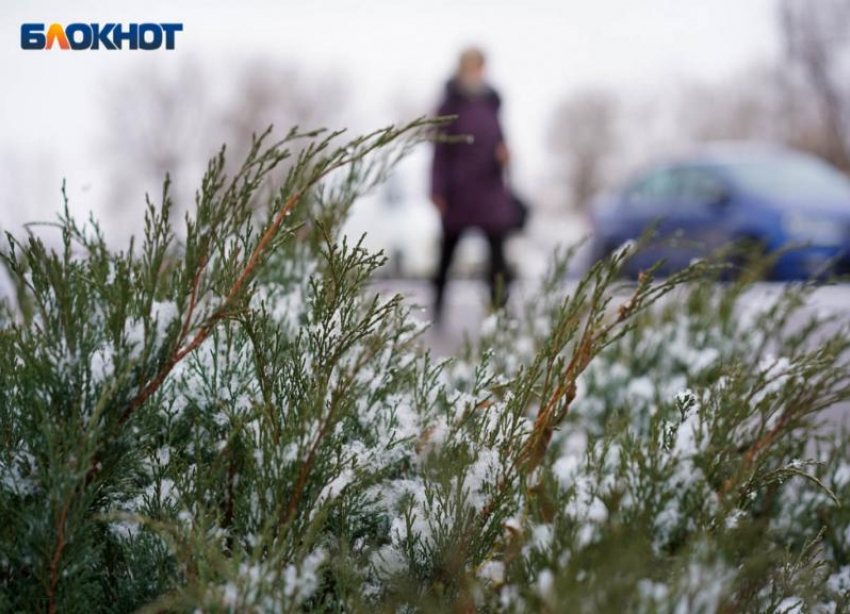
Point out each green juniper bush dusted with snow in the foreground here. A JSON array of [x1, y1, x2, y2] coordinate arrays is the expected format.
[[0, 121, 850, 614]]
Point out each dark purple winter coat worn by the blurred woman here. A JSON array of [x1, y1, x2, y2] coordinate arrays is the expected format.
[[431, 81, 517, 234]]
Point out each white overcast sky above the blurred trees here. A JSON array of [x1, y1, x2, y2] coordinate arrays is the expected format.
[[0, 0, 778, 238]]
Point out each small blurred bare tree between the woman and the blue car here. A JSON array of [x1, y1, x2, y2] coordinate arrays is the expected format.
[[549, 90, 618, 213]]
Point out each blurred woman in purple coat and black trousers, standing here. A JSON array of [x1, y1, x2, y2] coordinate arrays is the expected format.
[[431, 48, 518, 322]]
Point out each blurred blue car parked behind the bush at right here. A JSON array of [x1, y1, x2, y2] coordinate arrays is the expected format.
[[591, 145, 850, 280]]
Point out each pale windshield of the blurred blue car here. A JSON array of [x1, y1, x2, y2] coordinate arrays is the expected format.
[[729, 157, 850, 201]]
